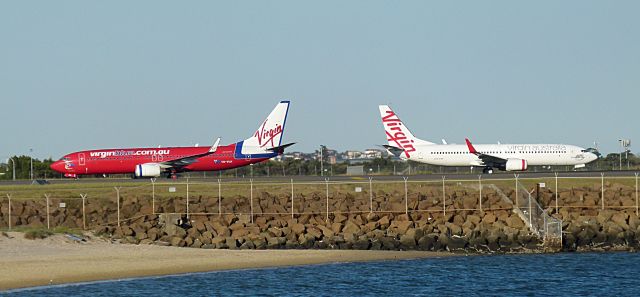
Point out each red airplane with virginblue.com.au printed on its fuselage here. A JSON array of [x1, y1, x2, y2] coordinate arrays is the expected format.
[[51, 101, 294, 178]]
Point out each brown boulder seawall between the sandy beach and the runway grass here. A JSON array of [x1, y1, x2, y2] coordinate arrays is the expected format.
[[0, 185, 640, 252]]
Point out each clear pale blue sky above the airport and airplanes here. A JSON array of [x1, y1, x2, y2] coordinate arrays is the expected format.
[[0, 1, 640, 160]]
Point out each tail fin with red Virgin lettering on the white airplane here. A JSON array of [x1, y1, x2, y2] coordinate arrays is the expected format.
[[379, 105, 434, 158]]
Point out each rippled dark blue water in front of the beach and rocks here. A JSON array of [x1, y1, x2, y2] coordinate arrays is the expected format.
[[5, 253, 640, 297]]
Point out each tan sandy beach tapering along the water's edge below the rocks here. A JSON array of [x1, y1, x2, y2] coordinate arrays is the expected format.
[[0, 232, 451, 290]]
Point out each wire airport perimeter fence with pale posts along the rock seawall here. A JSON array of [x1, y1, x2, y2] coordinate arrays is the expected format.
[[0, 173, 639, 236]]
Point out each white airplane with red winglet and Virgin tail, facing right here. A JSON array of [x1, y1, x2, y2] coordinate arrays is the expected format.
[[380, 105, 600, 173]]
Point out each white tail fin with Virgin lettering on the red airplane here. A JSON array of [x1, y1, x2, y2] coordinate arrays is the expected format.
[[242, 101, 289, 154]]
